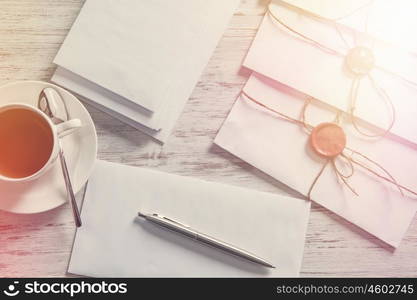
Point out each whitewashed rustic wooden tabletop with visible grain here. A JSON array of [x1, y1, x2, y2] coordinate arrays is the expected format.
[[0, 0, 417, 277]]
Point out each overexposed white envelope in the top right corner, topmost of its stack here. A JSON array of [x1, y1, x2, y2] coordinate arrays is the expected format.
[[283, 0, 417, 53]]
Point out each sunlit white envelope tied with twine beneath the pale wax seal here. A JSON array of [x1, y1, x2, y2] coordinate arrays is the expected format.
[[244, 1, 417, 144]]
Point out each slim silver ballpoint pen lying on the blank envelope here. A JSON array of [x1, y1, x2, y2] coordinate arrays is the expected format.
[[138, 212, 275, 268]]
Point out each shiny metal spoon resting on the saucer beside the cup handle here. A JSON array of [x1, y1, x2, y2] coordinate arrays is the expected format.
[[38, 88, 82, 227]]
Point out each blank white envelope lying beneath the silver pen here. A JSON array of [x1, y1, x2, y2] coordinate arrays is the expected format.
[[68, 161, 310, 277]]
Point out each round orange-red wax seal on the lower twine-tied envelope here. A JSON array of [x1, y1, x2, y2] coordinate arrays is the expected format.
[[310, 123, 346, 158]]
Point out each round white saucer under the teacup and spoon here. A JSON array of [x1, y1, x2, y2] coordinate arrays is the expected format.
[[0, 81, 97, 214]]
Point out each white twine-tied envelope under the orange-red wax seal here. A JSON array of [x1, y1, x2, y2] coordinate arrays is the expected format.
[[215, 73, 417, 247]]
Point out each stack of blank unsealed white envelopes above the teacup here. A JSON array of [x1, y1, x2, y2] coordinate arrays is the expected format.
[[52, 0, 240, 142]]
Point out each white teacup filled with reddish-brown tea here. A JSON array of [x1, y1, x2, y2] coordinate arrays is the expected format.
[[0, 103, 82, 182]]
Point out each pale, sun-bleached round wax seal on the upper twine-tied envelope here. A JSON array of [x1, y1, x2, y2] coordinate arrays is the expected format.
[[346, 47, 375, 75]]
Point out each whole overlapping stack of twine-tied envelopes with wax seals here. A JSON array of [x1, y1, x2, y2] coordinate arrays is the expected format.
[[215, 0, 417, 247]]
